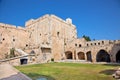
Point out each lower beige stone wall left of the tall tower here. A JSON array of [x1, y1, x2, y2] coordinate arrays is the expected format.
[[0, 23, 28, 59]]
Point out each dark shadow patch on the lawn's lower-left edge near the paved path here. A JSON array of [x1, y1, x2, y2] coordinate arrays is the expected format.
[[27, 73, 55, 80]]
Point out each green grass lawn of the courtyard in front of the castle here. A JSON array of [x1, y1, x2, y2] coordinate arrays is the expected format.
[[16, 63, 120, 80]]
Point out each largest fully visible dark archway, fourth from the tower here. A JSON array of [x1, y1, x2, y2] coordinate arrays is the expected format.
[[96, 50, 110, 62]]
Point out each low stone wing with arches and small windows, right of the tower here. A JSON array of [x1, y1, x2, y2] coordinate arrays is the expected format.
[[65, 38, 120, 62]]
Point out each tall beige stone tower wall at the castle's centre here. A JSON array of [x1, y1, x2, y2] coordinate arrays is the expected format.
[[26, 15, 77, 60]]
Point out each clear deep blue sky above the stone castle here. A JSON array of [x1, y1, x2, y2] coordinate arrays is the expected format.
[[0, 0, 120, 40]]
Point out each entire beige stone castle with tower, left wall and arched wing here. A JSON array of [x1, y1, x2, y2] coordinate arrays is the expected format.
[[0, 15, 120, 63]]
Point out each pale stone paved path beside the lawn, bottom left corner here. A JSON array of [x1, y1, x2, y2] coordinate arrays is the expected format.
[[0, 63, 32, 80]]
